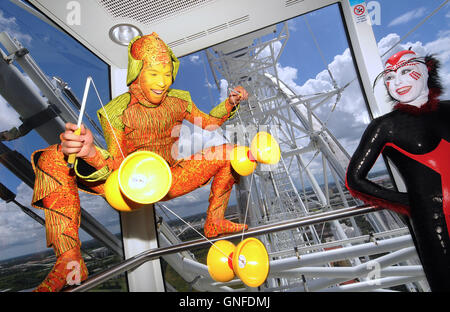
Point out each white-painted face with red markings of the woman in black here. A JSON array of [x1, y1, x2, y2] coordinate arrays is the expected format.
[[384, 54, 429, 107]]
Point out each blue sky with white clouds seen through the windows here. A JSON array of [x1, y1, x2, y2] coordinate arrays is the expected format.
[[0, 0, 450, 259]]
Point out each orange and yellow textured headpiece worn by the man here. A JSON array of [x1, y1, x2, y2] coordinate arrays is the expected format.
[[127, 32, 180, 86]]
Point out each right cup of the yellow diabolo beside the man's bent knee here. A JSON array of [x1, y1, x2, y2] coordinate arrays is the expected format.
[[250, 131, 281, 165]]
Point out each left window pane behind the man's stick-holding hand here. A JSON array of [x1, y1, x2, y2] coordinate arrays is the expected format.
[[0, 1, 127, 291]]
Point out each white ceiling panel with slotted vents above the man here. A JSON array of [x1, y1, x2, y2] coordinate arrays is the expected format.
[[29, 0, 338, 68]]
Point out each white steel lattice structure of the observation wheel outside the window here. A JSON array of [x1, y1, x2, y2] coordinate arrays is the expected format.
[[197, 23, 428, 291]]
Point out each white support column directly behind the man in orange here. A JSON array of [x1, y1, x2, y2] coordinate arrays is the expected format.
[[111, 67, 165, 292]]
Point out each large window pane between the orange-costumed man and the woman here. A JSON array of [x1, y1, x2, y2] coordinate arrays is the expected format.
[[157, 5, 398, 291]]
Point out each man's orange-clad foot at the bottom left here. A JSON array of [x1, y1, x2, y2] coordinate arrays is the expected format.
[[33, 247, 88, 292]]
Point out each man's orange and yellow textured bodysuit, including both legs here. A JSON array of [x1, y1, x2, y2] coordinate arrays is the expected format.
[[32, 33, 247, 291]]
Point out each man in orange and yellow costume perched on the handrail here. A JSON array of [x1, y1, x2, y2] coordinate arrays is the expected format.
[[32, 33, 248, 291]]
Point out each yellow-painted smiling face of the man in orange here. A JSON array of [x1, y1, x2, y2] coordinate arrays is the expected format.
[[139, 64, 172, 105]]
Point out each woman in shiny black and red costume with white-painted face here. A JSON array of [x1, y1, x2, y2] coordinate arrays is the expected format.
[[346, 50, 450, 291]]
